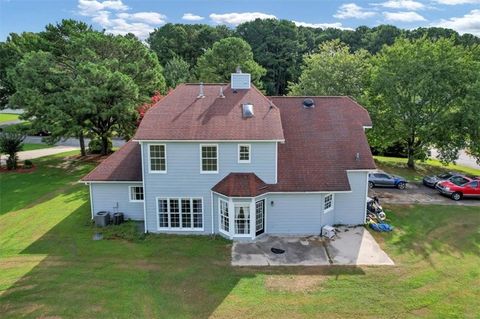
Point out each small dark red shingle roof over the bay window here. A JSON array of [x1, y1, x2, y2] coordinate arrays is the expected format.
[[212, 173, 268, 197]]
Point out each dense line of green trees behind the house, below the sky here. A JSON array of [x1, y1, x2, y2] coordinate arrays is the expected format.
[[0, 19, 480, 167]]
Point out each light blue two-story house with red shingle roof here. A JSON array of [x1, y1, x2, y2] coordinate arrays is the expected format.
[[82, 73, 375, 239]]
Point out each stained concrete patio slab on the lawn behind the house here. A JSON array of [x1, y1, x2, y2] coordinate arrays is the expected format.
[[232, 226, 394, 266]]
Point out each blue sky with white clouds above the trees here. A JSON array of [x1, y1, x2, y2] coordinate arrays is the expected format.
[[0, 0, 480, 41]]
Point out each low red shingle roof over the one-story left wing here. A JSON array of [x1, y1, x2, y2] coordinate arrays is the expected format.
[[81, 141, 142, 182]]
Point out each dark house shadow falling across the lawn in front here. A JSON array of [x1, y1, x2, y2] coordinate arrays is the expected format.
[[0, 203, 364, 318]]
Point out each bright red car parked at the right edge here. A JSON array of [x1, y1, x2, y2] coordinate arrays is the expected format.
[[435, 176, 480, 200]]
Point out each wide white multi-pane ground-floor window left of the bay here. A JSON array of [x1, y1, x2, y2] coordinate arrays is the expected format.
[[157, 198, 203, 230]]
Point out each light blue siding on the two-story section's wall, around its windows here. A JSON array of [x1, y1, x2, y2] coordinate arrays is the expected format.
[[143, 142, 276, 234]]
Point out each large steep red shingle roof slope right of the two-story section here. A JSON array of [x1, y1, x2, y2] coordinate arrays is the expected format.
[[270, 97, 375, 192]]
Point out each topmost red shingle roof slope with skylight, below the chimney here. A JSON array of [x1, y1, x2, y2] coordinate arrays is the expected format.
[[133, 84, 284, 141]]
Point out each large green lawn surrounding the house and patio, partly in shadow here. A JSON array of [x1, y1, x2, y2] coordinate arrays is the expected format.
[[0, 155, 480, 318]]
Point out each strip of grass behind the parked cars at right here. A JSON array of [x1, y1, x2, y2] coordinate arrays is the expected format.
[[374, 156, 480, 182]]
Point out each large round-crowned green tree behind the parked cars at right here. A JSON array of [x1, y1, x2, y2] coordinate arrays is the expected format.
[[368, 38, 473, 168]]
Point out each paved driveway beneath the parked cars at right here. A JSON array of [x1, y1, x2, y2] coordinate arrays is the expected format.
[[368, 183, 480, 206]]
